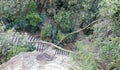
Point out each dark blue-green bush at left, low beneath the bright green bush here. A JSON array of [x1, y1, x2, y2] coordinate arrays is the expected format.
[[10, 19, 39, 33]]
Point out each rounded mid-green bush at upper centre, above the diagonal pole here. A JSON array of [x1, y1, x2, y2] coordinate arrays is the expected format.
[[54, 10, 72, 32]]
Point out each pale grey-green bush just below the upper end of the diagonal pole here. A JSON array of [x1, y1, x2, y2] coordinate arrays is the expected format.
[[93, 19, 113, 43]]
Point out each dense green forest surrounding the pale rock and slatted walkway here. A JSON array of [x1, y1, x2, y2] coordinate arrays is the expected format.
[[0, 0, 120, 70]]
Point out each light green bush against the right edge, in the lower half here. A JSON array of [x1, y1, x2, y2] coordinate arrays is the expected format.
[[100, 37, 120, 69]]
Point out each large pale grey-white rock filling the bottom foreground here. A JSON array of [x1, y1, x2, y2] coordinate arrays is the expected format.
[[0, 51, 70, 70]]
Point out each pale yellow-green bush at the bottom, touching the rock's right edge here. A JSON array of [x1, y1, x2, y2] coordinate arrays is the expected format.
[[71, 41, 98, 70]]
